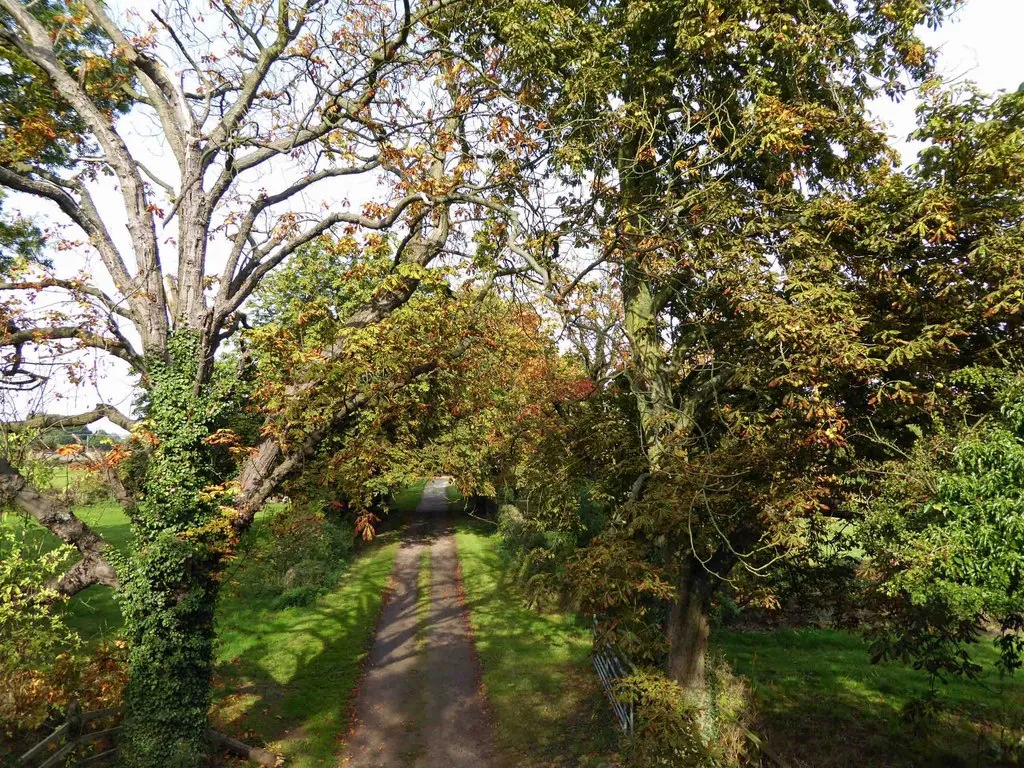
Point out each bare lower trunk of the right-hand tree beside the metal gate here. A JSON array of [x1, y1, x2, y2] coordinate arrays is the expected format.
[[667, 557, 713, 693]]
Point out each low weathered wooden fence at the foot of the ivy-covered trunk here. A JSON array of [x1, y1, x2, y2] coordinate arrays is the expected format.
[[17, 702, 284, 768]]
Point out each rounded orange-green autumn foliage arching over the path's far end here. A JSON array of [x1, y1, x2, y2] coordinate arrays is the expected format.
[[243, 231, 594, 538]]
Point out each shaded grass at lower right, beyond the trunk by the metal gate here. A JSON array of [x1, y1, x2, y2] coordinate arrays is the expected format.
[[713, 629, 1024, 768]]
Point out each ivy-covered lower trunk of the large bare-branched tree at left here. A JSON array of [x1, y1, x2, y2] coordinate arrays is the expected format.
[[120, 331, 229, 768]]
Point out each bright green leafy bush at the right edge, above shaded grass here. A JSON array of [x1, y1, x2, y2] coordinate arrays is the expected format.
[[859, 369, 1024, 679]]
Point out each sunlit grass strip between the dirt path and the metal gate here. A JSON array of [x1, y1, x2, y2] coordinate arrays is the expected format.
[[456, 521, 615, 767]]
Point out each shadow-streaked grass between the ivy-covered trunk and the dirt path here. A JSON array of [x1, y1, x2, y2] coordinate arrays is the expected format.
[[214, 534, 398, 768]]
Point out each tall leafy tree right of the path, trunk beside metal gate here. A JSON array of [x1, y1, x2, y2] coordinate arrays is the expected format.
[[452, 0, 954, 693]]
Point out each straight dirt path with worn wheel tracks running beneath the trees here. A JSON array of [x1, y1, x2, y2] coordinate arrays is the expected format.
[[342, 479, 494, 768]]
